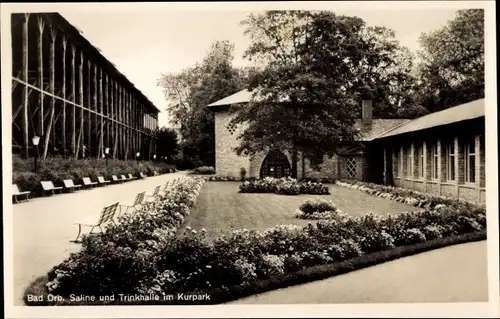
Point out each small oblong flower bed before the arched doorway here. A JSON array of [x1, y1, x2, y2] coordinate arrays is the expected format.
[[240, 177, 330, 195]]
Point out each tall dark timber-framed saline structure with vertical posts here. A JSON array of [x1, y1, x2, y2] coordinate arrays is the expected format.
[[11, 13, 160, 160]]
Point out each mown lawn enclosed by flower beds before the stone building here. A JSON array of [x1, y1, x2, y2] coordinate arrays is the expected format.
[[179, 182, 418, 237]]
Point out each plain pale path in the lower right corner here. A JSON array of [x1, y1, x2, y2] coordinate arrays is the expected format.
[[228, 240, 488, 304]]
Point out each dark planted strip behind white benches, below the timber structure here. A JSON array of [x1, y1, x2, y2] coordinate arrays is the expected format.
[[12, 156, 176, 195]]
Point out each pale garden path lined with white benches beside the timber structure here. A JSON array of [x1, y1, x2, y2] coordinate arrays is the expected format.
[[9, 172, 189, 305]]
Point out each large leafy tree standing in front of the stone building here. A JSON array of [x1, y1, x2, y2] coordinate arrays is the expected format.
[[230, 11, 418, 177]]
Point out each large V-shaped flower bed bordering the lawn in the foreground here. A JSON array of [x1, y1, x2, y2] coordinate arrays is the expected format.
[[29, 180, 486, 304]]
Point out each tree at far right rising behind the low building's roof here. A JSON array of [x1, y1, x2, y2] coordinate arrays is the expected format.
[[419, 9, 484, 112]]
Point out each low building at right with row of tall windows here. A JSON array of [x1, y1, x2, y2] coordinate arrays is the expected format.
[[373, 99, 486, 202]]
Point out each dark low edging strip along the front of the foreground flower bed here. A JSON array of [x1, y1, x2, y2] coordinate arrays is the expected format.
[[23, 230, 486, 306]]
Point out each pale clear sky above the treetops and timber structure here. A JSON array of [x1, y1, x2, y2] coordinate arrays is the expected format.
[[59, 2, 456, 126]]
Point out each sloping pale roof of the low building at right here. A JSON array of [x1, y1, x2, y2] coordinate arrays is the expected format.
[[376, 99, 485, 139]]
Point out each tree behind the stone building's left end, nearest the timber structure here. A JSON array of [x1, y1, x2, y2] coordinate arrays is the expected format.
[[158, 41, 249, 166]]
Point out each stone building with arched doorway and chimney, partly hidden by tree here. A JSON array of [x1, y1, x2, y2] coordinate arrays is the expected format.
[[209, 90, 408, 180]]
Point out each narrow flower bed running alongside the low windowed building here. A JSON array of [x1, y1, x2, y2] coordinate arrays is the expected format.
[[335, 181, 486, 213]]
